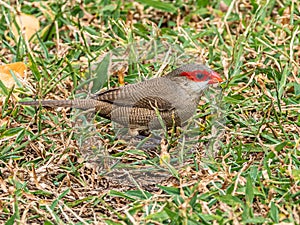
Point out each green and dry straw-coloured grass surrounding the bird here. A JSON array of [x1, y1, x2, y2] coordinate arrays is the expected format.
[[0, 0, 300, 224]]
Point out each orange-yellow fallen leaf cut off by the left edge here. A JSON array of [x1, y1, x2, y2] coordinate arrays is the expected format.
[[0, 62, 26, 88]]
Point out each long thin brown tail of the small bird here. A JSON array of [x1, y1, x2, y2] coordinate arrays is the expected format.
[[19, 99, 99, 109]]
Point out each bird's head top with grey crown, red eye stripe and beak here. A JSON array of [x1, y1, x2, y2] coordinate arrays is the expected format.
[[175, 64, 222, 84]]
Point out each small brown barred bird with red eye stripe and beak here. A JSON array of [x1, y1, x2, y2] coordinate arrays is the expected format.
[[19, 63, 222, 136]]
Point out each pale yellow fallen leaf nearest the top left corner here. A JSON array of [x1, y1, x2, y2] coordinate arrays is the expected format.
[[12, 13, 40, 40]]
